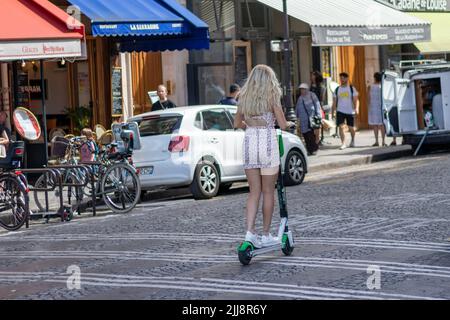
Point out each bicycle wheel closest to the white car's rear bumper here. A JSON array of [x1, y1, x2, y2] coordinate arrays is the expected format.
[[101, 163, 141, 213]]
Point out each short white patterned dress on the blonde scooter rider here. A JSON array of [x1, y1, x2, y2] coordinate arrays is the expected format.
[[244, 112, 280, 174]]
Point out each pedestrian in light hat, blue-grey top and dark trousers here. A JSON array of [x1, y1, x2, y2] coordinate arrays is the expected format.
[[296, 83, 322, 156]]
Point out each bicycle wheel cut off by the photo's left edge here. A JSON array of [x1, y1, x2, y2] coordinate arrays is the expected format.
[[0, 175, 28, 231]]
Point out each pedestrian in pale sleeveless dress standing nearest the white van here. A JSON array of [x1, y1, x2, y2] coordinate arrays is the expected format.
[[367, 72, 387, 147]]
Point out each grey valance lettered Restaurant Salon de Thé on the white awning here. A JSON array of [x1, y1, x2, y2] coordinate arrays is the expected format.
[[311, 25, 431, 47]]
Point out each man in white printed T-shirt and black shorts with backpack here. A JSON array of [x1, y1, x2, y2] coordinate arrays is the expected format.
[[332, 72, 359, 150]]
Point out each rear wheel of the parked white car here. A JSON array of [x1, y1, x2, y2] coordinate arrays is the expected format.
[[190, 160, 220, 199]]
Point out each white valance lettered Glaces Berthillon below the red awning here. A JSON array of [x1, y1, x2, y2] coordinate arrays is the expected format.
[[0, 39, 82, 61]]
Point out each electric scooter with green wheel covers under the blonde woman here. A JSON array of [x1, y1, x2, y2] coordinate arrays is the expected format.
[[238, 129, 294, 265]]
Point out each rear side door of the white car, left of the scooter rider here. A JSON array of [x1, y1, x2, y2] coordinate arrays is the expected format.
[[202, 108, 234, 177]]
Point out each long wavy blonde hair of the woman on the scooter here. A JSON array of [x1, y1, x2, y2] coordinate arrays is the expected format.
[[239, 64, 282, 118]]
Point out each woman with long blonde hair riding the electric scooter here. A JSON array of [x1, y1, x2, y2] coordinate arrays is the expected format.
[[234, 65, 293, 247]]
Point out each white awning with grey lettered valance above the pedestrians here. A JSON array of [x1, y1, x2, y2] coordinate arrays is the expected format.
[[258, 0, 431, 46]]
